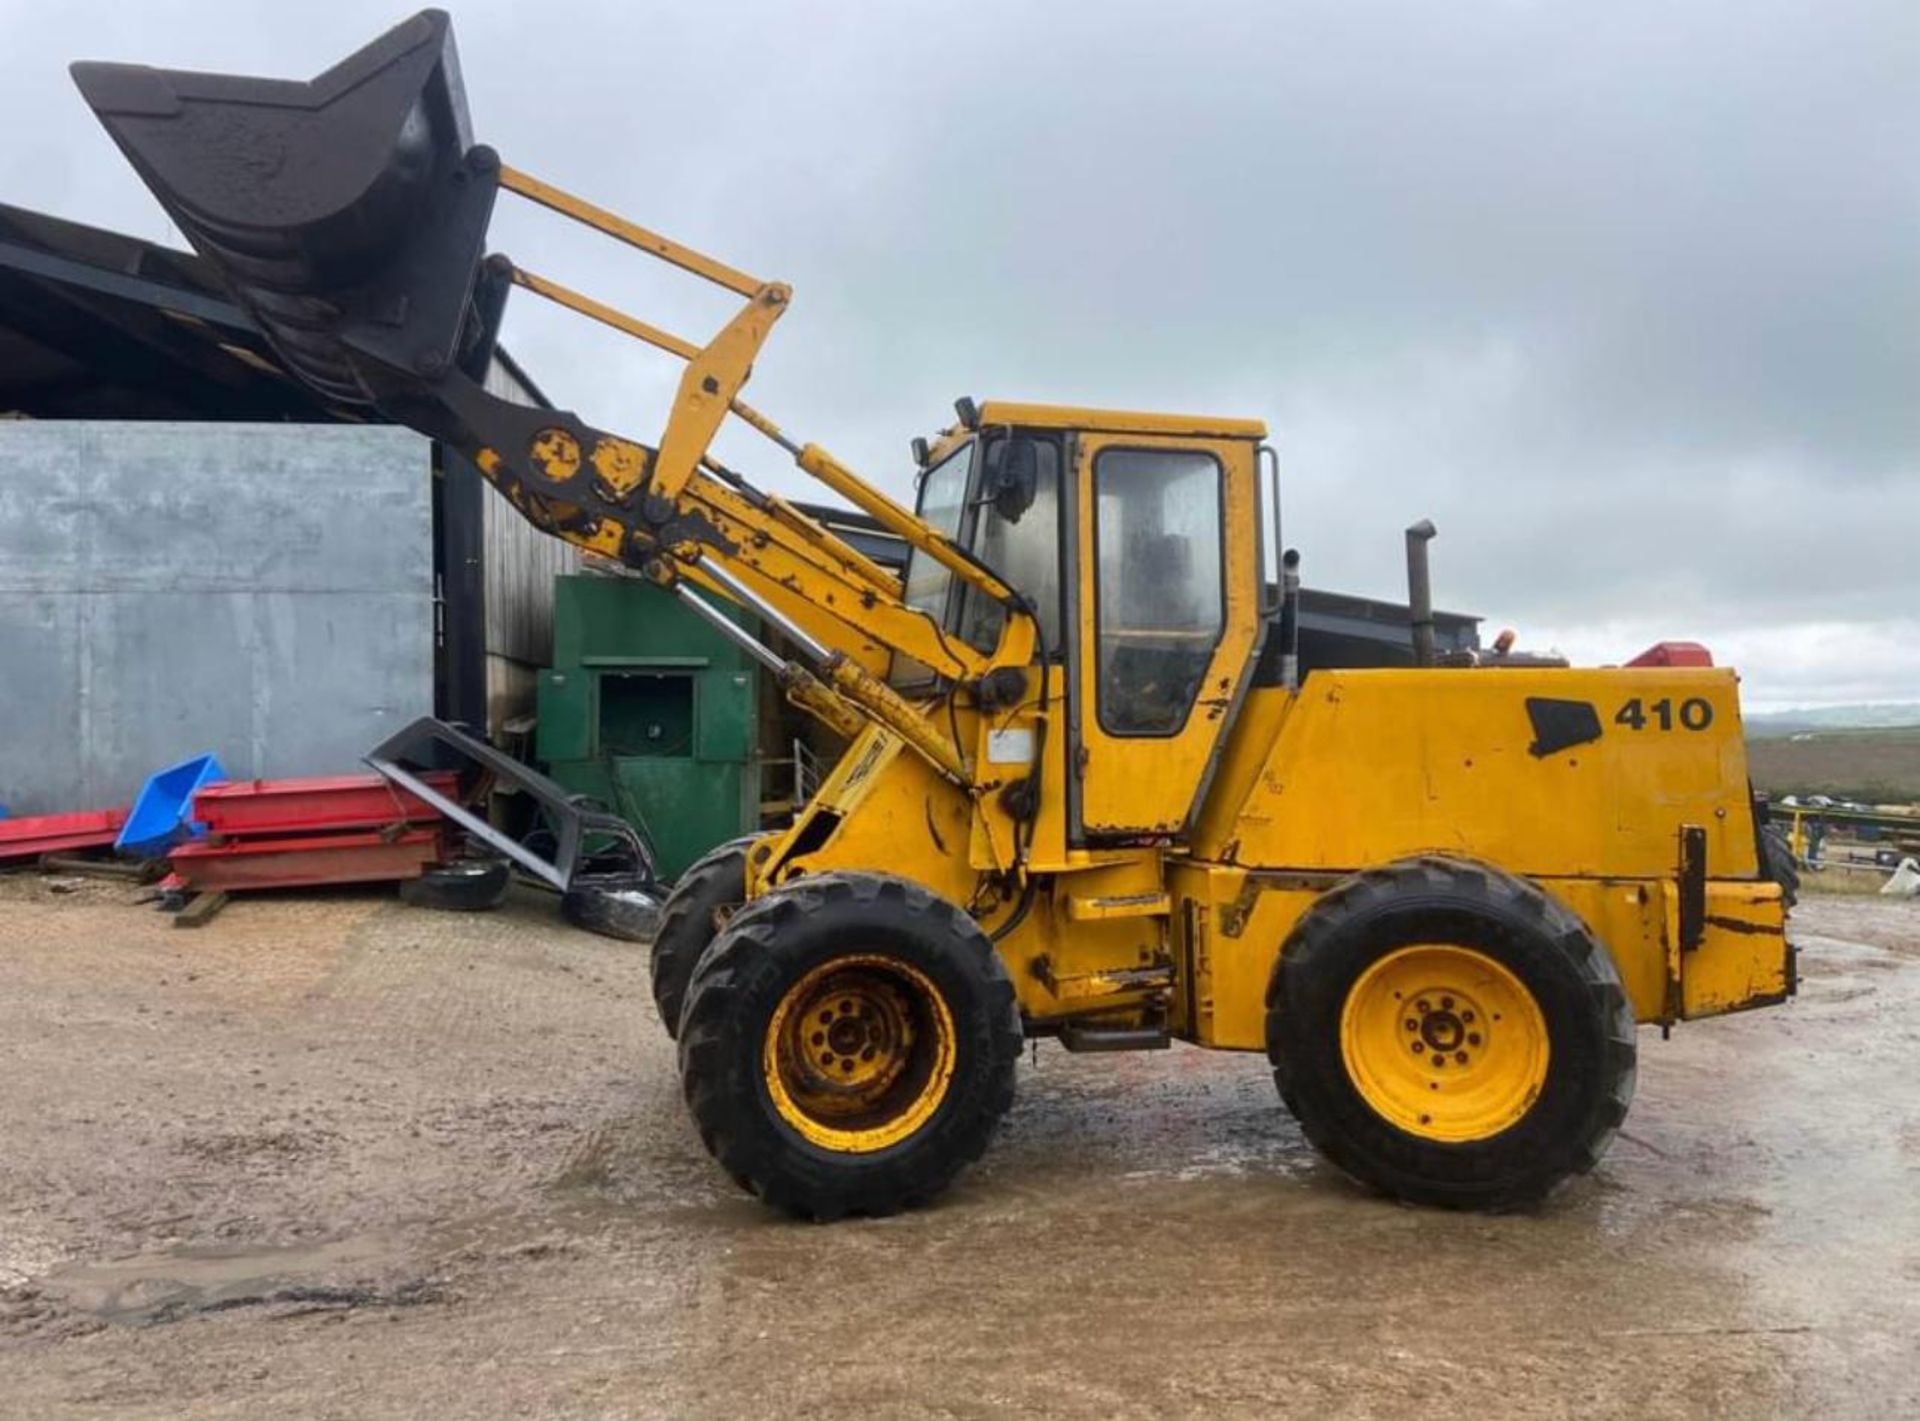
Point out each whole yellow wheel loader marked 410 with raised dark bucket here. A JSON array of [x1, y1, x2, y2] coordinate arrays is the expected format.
[[73, 12, 1793, 1219]]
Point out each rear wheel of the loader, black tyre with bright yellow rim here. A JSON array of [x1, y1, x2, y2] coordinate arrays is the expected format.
[[1267, 858, 1636, 1210]]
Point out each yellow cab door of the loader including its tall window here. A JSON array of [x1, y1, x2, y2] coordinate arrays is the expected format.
[[1071, 434, 1260, 845]]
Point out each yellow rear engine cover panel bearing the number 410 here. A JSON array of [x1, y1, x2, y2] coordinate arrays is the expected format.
[[1192, 668, 1757, 878]]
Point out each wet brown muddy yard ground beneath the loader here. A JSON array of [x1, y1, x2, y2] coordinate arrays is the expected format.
[[0, 874, 1920, 1421]]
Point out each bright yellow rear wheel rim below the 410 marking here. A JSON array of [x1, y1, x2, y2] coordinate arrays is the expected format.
[[1340, 945, 1548, 1143]]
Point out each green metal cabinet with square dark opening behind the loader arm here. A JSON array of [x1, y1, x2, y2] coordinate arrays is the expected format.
[[534, 576, 760, 878]]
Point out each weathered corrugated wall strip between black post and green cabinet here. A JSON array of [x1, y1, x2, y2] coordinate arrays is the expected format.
[[482, 361, 580, 730]]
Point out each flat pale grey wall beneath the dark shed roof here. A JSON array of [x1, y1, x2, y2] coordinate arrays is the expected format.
[[0, 421, 434, 814]]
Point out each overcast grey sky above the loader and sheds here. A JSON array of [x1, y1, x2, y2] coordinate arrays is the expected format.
[[0, 0, 1920, 709]]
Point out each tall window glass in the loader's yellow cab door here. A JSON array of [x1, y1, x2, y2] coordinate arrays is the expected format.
[[1092, 449, 1225, 735]]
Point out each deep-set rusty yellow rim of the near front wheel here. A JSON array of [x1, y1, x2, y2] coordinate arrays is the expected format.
[[760, 956, 956, 1154]]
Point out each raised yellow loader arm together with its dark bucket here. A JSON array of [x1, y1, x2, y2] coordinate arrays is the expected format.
[[73, 10, 1037, 789]]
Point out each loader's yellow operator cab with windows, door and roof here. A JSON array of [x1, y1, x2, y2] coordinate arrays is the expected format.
[[893, 399, 1265, 843]]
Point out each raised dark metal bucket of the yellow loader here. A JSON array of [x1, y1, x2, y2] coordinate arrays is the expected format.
[[73, 10, 499, 405]]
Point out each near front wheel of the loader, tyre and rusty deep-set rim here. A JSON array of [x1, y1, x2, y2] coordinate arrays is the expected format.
[[680, 874, 1023, 1219]]
